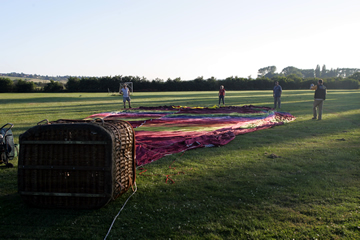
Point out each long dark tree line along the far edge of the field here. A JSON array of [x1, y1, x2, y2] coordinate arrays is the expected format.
[[0, 67, 360, 93]]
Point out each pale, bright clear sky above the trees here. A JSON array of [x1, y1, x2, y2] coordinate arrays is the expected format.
[[0, 0, 360, 80]]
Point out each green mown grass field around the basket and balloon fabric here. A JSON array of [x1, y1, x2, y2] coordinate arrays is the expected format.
[[0, 90, 360, 239]]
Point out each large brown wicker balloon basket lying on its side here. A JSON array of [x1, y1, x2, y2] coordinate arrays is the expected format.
[[18, 120, 136, 209]]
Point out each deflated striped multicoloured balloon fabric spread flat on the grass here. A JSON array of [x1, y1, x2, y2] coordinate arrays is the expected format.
[[86, 105, 295, 166]]
